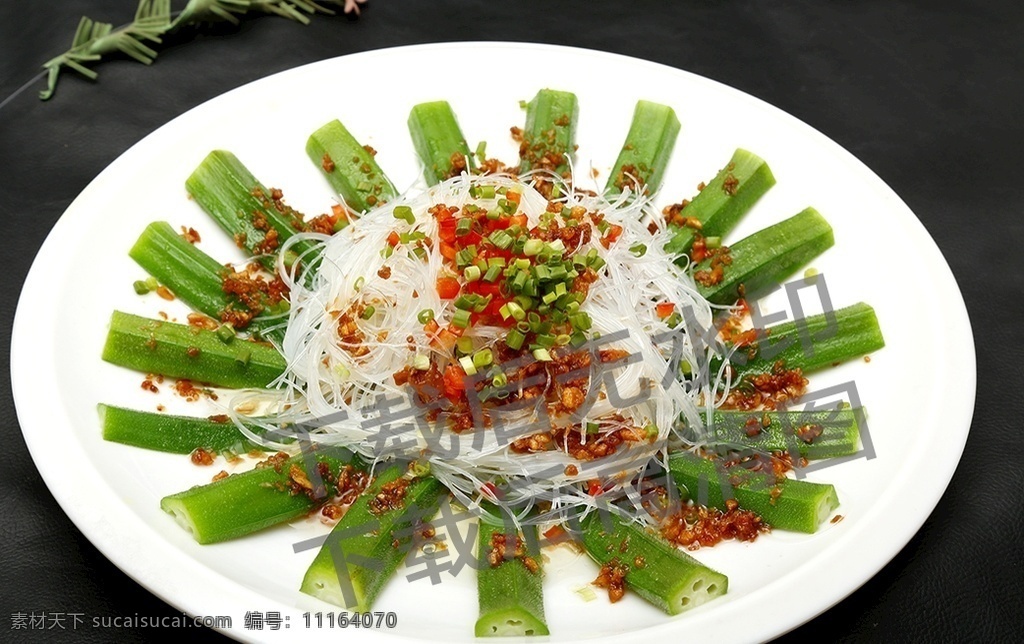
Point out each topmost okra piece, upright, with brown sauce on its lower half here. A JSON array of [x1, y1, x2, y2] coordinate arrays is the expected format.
[[519, 89, 580, 175]]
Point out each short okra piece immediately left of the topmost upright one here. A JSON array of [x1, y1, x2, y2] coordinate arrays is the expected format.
[[409, 100, 475, 185]]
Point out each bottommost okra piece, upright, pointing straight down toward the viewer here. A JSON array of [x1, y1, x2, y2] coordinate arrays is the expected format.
[[476, 513, 549, 637]]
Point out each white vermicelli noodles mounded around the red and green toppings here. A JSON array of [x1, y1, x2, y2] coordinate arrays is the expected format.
[[236, 174, 722, 516]]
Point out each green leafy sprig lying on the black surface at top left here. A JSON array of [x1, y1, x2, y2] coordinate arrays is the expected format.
[[39, 0, 367, 100]]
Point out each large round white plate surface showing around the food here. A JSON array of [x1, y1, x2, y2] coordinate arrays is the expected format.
[[11, 43, 975, 642]]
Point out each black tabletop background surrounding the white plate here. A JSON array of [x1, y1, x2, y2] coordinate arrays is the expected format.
[[0, 0, 1024, 642]]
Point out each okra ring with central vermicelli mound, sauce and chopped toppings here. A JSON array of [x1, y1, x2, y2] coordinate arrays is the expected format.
[[105, 89, 883, 637]]
